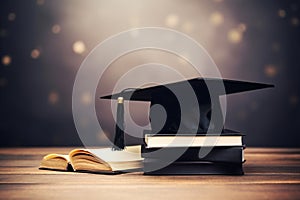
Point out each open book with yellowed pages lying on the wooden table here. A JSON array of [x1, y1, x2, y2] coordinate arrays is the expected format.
[[40, 145, 143, 173]]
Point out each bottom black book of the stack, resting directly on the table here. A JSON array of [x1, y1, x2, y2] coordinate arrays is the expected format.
[[144, 162, 244, 175]]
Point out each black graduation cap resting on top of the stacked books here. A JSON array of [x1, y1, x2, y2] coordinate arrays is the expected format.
[[100, 78, 274, 133]]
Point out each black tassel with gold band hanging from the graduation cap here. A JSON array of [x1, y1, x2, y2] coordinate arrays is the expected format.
[[113, 97, 125, 150]]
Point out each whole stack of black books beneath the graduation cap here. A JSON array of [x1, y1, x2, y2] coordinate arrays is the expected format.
[[142, 130, 245, 175]]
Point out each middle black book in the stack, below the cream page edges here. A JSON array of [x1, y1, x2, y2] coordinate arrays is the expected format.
[[141, 145, 245, 163]]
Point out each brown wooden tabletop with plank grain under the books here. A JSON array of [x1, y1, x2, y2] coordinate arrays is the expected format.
[[0, 148, 300, 200]]
